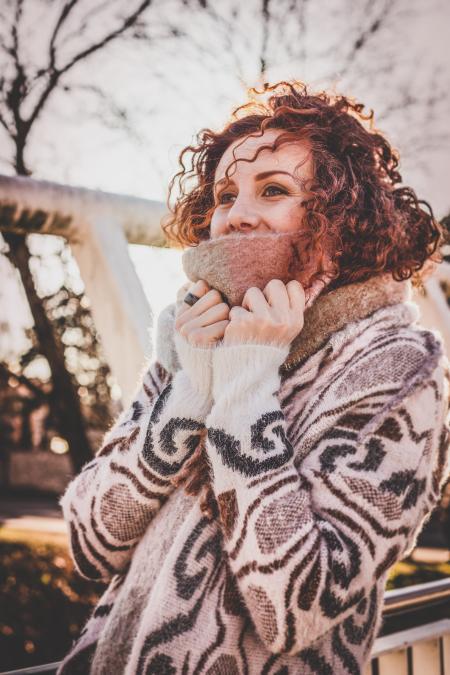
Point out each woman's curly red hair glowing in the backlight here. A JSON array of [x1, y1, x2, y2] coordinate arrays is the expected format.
[[163, 82, 443, 518]]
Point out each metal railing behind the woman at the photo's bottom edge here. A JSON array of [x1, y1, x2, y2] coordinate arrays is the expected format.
[[0, 579, 450, 675]]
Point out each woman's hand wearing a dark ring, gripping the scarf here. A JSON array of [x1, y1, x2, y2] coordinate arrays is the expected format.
[[175, 279, 230, 347]]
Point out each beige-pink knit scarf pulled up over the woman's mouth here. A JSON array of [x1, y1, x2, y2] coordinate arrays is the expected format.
[[178, 232, 410, 369]]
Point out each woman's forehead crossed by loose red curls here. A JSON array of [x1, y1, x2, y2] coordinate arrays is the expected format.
[[215, 129, 312, 181]]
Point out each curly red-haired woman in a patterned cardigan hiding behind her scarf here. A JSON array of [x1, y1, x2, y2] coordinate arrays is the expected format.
[[59, 83, 449, 675]]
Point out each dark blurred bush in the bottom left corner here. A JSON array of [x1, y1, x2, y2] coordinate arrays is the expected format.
[[0, 540, 103, 670]]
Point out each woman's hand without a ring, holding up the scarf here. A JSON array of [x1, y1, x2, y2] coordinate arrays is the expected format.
[[223, 279, 307, 346]]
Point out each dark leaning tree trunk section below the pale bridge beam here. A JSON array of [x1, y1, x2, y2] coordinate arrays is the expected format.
[[3, 232, 93, 472]]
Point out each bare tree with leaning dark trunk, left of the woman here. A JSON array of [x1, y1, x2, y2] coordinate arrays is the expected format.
[[0, 0, 171, 470]]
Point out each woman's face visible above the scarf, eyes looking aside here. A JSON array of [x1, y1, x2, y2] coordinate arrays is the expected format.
[[211, 129, 313, 239]]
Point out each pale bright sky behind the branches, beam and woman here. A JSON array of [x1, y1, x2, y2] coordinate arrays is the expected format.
[[0, 0, 450, 372]]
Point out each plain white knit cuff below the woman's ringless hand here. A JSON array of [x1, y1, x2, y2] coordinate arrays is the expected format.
[[212, 342, 289, 402]]
